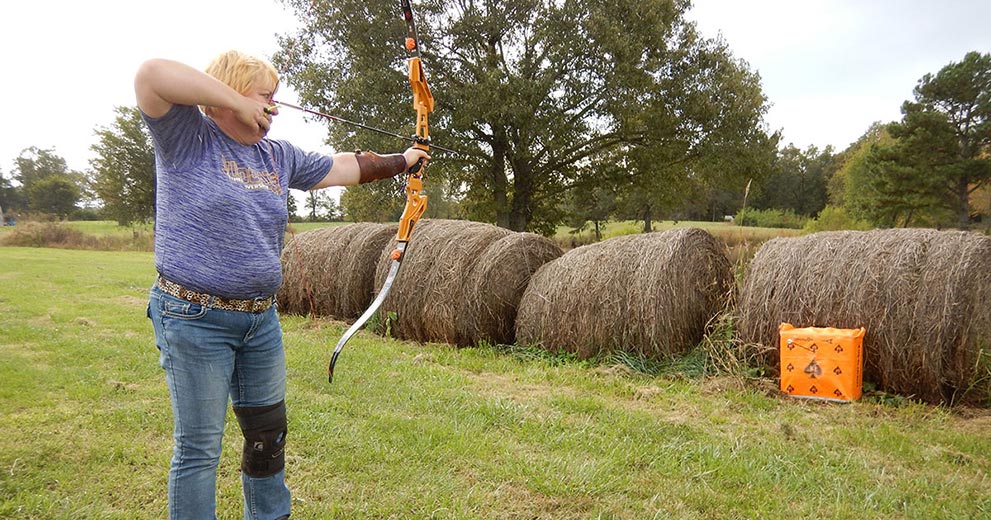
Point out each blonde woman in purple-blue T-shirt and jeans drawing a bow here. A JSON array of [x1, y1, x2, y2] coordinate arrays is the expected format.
[[134, 51, 429, 520]]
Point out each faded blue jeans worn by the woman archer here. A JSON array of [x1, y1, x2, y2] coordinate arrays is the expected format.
[[148, 287, 290, 520]]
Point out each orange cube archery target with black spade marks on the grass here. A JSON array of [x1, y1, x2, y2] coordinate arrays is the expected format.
[[778, 323, 866, 401]]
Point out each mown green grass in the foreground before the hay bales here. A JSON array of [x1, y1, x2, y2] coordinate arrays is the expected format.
[[0, 247, 991, 519]]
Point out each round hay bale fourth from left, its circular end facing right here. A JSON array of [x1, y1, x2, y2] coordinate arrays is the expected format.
[[516, 228, 734, 358]]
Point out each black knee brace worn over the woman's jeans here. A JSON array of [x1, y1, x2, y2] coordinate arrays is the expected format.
[[234, 401, 288, 478]]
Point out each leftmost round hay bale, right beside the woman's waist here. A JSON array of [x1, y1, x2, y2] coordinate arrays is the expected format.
[[279, 223, 398, 319]]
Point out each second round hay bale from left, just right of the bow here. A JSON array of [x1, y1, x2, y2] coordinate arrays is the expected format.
[[375, 219, 512, 345]]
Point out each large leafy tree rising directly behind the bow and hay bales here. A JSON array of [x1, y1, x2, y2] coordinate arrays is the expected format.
[[274, 0, 766, 232]]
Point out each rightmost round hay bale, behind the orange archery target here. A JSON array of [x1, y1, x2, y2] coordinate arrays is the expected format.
[[738, 229, 991, 403]]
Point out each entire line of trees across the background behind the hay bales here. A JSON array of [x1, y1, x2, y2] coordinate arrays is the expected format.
[[0, 0, 991, 233]]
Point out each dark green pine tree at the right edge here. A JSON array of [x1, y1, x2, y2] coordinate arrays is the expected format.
[[889, 52, 991, 229]]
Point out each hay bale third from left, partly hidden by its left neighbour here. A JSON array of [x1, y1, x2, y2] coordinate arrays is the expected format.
[[458, 233, 564, 344]]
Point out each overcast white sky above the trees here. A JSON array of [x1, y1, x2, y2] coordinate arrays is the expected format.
[[0, 0, 991, 175]]
